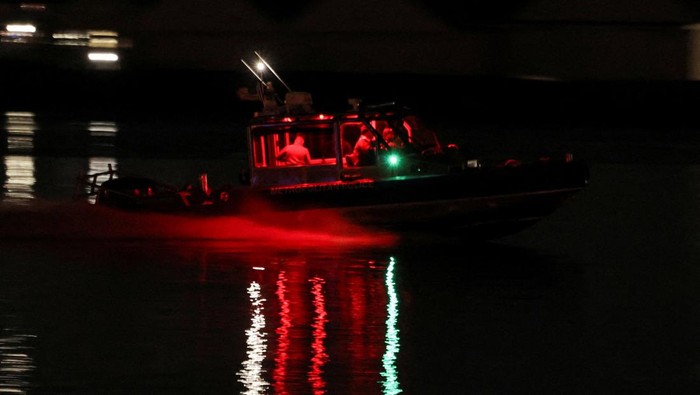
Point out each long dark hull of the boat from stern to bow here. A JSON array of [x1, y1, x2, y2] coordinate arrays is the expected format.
[[91, 157, 588, 239]]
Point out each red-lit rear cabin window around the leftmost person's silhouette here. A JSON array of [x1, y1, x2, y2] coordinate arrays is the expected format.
[[251, 123, 338, 167]]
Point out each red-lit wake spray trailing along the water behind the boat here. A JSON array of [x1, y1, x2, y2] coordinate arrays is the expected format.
[[0, 201, 397, 248]]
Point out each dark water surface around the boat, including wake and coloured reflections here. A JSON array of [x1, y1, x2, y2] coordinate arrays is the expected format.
[[0, 86, 700, 394]]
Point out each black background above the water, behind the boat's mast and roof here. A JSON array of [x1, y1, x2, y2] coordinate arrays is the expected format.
[[0, 0, 700, 154]]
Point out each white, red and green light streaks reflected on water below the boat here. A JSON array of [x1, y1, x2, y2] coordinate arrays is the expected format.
[[231, 258, 401, 395]]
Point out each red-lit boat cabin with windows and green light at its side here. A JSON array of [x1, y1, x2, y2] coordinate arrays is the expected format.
[[248, 102, 442, 187]]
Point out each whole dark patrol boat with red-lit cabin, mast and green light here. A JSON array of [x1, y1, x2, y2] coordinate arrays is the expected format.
[[78, 53, 589, 239]]
